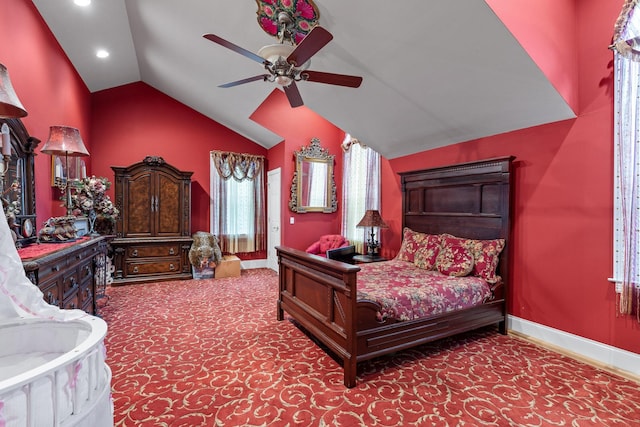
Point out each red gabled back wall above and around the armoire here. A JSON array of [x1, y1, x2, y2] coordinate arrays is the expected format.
[[91, 83, 267, 236]]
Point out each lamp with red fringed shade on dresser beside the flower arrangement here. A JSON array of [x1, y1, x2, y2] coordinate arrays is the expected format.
[[41, 126, 89, 217]]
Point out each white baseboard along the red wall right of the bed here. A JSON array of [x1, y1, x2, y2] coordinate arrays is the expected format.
[[507, 316, 640, 378]]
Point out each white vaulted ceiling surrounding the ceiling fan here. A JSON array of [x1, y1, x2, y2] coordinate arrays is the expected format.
[[33, 0, 574, 158]]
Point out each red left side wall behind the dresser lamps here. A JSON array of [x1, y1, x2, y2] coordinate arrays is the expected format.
[[0, 0, 92, 229]]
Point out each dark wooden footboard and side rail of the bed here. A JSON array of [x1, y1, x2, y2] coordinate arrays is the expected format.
[[276, 247, 505, 387]]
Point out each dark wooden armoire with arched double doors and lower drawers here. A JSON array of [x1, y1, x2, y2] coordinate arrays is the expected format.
[[111, 156, 193, 284]]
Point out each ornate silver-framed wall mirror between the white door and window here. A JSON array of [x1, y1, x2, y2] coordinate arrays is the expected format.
[[289, 138, 338, 213]]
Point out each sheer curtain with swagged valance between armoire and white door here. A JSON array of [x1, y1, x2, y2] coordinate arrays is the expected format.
[[211, 151, 266, 253]]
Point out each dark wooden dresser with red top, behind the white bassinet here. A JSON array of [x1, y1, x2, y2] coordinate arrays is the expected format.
[[20, 237, 108, 314]]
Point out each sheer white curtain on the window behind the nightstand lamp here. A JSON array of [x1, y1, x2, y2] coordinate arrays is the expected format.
[[342, 134, 380, 253]]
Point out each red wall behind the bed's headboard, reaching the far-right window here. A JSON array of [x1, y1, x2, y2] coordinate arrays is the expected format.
[[383, 0, 640, 353]]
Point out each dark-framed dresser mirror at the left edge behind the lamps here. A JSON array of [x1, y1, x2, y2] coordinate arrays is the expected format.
[[0, 119, 40, 248]]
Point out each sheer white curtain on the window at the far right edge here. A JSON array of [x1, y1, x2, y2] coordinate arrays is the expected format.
[[610, 0, 640, 321]]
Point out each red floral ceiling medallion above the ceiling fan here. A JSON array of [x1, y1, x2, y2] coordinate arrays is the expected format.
[[256, 0, 320, 45]]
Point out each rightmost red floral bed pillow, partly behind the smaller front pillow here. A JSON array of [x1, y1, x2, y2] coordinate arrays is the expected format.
[[442, 234, 504, 283]]
